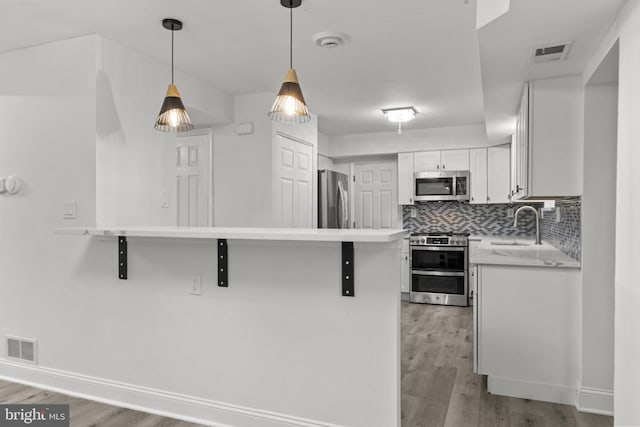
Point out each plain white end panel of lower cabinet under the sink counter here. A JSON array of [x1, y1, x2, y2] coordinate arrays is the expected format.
[[473, 265, 580, 404]]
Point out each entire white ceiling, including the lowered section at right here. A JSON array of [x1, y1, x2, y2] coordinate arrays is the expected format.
[[0, 0, 623, 136]]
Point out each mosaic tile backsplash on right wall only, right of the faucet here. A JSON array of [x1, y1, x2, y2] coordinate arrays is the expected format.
[[540, 197, 582, 261]]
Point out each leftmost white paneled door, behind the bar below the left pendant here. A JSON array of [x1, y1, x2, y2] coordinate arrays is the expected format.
[[176, 135, 210, 227]]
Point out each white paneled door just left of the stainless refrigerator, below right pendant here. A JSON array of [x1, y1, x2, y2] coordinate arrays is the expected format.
[[274, 135, 313, 228]]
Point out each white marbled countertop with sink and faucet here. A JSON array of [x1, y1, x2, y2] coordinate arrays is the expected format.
[[469, 236, 580, 268]]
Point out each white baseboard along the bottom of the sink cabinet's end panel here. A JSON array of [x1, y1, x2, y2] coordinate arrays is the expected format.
[[487, 376, 576, 405]]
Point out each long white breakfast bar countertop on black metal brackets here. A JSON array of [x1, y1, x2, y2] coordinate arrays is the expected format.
[[55, 227, 407, 243]]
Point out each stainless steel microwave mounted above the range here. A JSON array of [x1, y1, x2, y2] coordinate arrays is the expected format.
[[414, 171, 469, 201]]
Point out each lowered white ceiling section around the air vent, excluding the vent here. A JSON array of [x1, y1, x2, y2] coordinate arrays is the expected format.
[[478, 0, 624, 141]]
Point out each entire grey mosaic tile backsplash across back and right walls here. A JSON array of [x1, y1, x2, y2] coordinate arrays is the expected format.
[[402, 197, 582, 261]]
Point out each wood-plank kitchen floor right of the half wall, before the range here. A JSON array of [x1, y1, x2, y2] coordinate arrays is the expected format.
[[402, 303, 613, 427]]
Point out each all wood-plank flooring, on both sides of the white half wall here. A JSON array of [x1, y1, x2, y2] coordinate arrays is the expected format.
[[0, 303, 613, 427]]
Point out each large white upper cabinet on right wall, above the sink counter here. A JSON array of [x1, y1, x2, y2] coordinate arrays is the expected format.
[[513, 75, 584, 199]]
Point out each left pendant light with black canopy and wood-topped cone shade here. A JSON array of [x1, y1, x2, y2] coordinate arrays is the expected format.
[[155, 18, 193, 132]]
